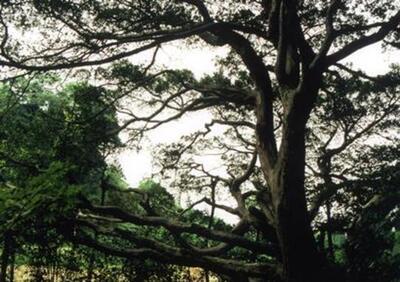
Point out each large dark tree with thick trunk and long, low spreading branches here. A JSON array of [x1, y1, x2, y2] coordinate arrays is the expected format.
[[0, 0, 400, 281]]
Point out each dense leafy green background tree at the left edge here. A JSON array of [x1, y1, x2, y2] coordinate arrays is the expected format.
[[0, 76, 120, 281]]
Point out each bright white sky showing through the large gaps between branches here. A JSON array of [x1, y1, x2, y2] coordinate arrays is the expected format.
[[118, 44, 400, 187]]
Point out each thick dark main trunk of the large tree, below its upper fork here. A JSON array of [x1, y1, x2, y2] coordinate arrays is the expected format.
[[259, 82, 330, 282]]
